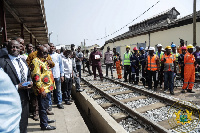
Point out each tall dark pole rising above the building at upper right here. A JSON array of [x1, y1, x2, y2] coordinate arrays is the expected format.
[[193, 0, 197, 46]]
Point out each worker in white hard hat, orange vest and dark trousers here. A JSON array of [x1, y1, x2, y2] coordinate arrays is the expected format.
[[145, 47, 160, 91]]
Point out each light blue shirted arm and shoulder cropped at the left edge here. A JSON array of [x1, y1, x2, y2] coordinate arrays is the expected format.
[[0, 68, 22, 133]]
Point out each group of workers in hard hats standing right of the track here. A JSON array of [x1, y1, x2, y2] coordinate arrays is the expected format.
[[104, 39, 200, 95]]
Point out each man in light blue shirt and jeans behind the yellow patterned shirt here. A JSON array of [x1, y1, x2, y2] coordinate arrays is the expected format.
[[49, 43, 64, 109]]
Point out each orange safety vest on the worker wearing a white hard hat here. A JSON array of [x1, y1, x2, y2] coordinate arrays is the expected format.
[[147, 55, 159, 71]]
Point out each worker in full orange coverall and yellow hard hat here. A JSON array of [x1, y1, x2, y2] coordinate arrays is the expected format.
[[181, 44, 196, 93]]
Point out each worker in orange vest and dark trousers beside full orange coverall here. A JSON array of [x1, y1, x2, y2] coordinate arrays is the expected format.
[[161, 46, 176, 95]]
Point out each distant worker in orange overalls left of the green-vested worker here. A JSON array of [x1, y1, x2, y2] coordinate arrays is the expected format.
[[113, 48, 122, 79]]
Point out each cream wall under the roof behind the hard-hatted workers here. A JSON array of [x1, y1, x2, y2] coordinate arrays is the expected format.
[[103, 22, 200, 58]]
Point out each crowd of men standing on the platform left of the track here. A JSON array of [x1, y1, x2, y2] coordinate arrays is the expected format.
[[0, 37, 91, 133]]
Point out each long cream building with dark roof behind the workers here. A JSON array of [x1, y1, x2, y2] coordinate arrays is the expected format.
[[101, 7, 200, 58]]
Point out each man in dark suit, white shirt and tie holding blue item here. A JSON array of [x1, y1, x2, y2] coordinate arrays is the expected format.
[[0, 40, 32, 133]]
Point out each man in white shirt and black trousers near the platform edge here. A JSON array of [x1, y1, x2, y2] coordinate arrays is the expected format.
[[63, 50, 73, 105]]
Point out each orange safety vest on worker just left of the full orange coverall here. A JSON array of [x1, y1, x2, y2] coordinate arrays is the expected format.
[[162, 54, 176, 71]]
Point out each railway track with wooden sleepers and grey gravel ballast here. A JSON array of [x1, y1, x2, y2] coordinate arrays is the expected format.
[[82, 76, 200, 133]]
